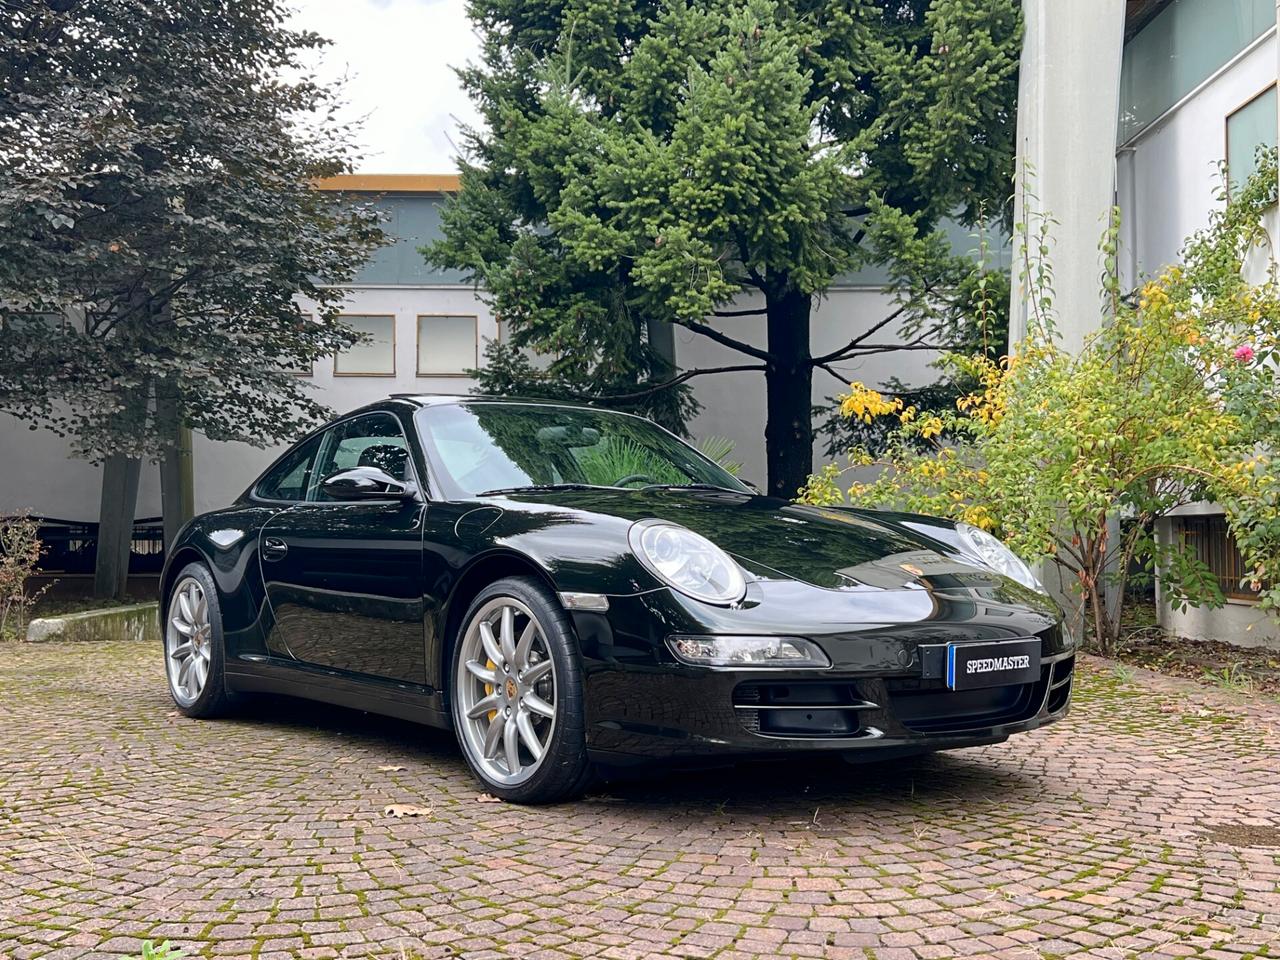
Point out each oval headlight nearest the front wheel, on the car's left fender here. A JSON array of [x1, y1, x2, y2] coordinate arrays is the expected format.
[[627, 520, 746, 604]]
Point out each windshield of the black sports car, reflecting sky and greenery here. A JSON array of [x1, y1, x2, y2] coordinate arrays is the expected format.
[[417, 402, 750, 497]]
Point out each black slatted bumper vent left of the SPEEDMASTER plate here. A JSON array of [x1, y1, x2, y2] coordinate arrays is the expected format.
[[733, 681, 879, 737]]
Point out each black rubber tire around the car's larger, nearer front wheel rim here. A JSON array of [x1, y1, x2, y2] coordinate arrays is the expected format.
[[449, 577, 593, 804]]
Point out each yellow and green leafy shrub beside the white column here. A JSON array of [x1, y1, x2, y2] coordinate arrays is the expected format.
[[800, 155, 1280, 653]]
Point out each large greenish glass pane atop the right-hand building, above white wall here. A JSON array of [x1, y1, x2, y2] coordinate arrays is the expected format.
[[1120, 0, 1276, 143]]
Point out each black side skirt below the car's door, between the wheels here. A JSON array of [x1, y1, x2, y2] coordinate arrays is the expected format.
[[227, 654, 453, 730]]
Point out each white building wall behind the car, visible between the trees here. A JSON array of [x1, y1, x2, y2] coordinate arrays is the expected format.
[[0, 287, 936, 522]]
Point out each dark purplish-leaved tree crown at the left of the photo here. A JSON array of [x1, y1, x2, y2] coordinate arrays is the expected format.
[[0, 0, 381, 458]]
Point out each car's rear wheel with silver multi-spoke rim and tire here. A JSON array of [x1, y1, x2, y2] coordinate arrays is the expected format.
[[164, 563, 232, 717]]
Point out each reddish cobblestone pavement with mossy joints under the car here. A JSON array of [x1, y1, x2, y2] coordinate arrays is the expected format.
[[0, 644, 1280, 960]]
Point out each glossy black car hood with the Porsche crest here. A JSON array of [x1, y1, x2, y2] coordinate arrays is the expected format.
[[494, 489, 1009, 590]]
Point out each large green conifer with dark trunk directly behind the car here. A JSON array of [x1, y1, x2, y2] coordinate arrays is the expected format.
[[426, 0, 1021, 497]]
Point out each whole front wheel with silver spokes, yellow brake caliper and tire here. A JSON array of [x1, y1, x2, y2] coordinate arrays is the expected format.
[[451, 577, 590, 804]]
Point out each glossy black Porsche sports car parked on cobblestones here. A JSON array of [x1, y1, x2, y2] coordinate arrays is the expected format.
[[160, 397, 1074, 803]]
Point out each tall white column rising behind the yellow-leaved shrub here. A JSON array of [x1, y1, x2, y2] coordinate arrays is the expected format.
[[1010, 0, 1125, 351]]
